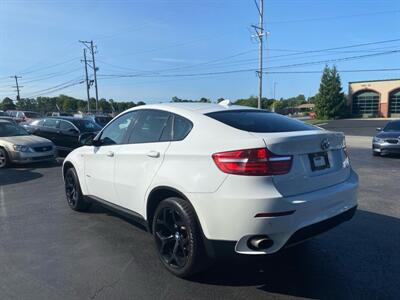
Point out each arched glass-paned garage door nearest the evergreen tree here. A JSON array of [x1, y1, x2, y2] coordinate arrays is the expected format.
[[352, 91, 379, 117]]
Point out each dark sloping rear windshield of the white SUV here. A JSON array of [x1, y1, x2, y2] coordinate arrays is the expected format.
[[206, 109, 318, 132]]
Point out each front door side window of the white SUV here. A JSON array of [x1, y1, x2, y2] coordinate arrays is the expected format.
[[100, 110, 139, 145]]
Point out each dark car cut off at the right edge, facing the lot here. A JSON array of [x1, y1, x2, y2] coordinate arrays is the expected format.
[[372, 120, 400, 156]]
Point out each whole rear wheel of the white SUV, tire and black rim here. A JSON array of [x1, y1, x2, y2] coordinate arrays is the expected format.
[[152, 197, 208, 278]]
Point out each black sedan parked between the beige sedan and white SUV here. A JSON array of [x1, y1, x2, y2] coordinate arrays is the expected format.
[[24, 117, 101, 151]]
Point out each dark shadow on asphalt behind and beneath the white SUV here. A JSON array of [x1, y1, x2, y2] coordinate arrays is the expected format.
[[192, 210, 400, 299]]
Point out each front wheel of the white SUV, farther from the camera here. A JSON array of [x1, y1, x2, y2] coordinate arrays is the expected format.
[[64, 168, 90, 211]]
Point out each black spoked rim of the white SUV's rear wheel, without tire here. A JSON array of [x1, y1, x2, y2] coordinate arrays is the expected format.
[[155, 207, 189, 269]]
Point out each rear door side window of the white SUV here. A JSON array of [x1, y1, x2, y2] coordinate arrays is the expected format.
[[129, 110, 171, 144]]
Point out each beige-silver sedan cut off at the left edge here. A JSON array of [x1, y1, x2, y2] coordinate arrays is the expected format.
[[0, 119, 57, 169]]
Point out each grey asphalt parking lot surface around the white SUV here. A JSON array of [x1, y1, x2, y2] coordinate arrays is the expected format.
[[0, 120, 400, 299]]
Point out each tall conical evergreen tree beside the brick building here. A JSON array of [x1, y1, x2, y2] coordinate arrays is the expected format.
[[314, 66, 347, 119]]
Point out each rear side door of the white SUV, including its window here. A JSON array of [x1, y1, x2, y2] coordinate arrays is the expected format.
[[115, 109, 173, 215]]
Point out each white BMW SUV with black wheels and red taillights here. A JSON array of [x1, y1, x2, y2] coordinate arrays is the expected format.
[[63, 102, 358, 277]]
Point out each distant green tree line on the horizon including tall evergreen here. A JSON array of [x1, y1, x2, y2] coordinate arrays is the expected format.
[[0, 66, 350, 119]]
